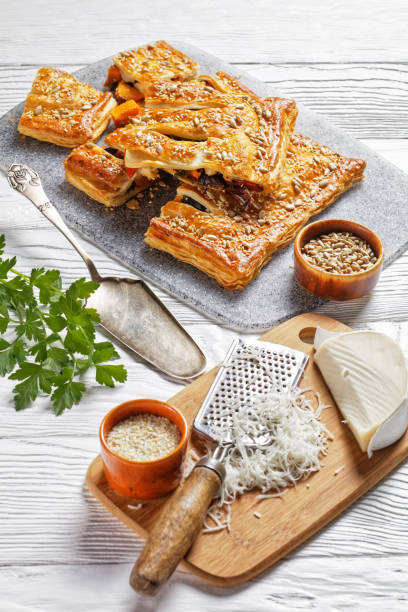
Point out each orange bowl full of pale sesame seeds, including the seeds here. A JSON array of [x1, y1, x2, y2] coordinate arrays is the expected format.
[[99, 399, 189, 500]]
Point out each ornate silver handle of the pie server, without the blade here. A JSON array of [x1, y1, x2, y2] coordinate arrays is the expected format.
[[7, 164, 101, 282]]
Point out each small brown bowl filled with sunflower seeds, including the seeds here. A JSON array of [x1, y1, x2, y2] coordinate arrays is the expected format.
[[294, 219, 384, 301]]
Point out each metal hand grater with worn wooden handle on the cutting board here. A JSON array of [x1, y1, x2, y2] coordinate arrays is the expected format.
[[130, 339, 309, 595]]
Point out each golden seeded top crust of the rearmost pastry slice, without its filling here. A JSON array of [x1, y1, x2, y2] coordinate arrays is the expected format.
[[113, 40, 199, 93]]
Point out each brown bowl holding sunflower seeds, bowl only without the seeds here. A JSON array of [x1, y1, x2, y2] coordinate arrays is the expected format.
[[294, 219, 384, 301]]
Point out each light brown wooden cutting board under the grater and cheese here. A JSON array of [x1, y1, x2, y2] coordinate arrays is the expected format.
[[86, 314, 408, 586]]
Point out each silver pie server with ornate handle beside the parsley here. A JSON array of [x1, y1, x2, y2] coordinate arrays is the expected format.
[[7, 164, 206, 379]]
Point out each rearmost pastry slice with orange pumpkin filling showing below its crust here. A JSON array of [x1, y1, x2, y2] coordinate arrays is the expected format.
[[105, 40, 199, 100]]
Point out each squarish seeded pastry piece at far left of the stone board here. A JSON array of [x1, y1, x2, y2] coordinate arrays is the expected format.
[[18, 68, 116, 147]]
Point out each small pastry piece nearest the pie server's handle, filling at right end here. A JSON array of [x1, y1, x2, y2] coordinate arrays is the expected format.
[[64, 143, 150, 208]]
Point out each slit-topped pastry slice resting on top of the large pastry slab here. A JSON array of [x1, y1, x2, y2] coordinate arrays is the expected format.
[[106, 88, 297, 200]]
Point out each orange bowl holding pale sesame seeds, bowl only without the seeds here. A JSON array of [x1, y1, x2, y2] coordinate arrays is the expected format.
[[99, 399, 189, 499]]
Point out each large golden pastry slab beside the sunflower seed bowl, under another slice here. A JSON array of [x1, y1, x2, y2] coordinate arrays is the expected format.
[[145, 133, 365, 289]]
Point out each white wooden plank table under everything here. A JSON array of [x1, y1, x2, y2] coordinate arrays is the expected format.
[[0, 0, 408, 612]]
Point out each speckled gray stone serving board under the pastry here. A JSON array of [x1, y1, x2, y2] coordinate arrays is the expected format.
[[0, 41, 408, 331]]
